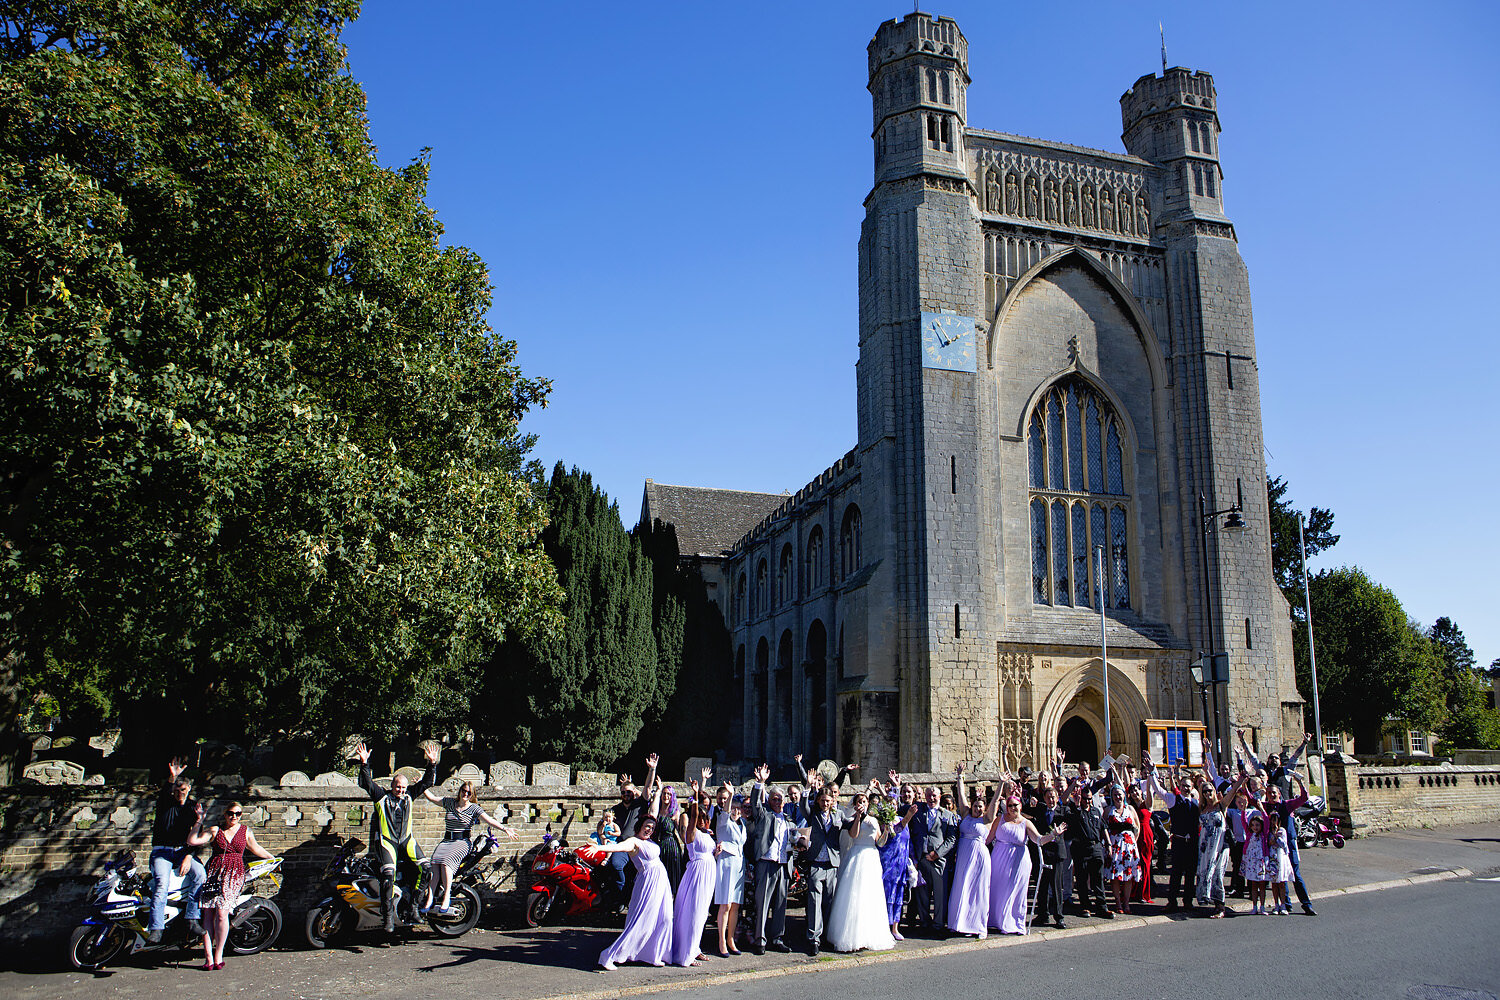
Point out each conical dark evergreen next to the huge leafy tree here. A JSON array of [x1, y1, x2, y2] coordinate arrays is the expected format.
[[474, 462, 672, 769]]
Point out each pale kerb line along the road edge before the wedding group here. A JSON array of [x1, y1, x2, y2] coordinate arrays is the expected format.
[[536, 868, 1475, 1000]]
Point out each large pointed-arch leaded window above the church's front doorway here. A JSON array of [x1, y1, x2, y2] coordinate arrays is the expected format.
[[1026, 375, 1131, 610]]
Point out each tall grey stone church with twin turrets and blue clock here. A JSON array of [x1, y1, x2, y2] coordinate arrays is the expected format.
[[642, 13, 1302, 771]]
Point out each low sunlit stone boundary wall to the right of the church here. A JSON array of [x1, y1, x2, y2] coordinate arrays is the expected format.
[[1326, 756, 1500, 834]]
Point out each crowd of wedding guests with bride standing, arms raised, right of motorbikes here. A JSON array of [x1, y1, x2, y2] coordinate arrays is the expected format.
[[578, 732, 1316, 972]]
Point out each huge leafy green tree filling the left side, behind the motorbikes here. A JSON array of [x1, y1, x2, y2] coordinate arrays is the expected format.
[[0, 0, 557, 773]]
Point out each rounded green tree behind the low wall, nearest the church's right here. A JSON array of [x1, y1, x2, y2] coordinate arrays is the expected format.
[[1293, 567, 1445, 753]]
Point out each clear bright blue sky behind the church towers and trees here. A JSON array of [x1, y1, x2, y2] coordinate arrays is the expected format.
[[345, 0, 1500, 664]]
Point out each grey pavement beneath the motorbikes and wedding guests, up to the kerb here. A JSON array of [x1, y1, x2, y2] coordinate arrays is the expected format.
[[0, 823, 1500, 1000]]
